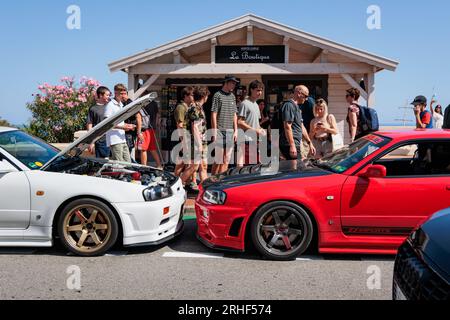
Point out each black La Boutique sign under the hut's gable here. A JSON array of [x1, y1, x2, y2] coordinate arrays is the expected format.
[[216, 46, 286, 63]]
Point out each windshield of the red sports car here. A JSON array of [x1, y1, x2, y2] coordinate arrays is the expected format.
[[314, 134, 391, 173]]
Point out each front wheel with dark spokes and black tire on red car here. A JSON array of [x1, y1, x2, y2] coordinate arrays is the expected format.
[[250, 201, 314, 261]]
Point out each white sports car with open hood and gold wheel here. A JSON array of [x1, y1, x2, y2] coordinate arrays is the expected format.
[[0, 95, 186, 256]]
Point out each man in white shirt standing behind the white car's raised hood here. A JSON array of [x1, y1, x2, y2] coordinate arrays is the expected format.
[[105, 84, 136, 162]]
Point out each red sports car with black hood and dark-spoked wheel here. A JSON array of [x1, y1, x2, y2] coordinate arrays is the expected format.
[[195, 130, 450, 260]]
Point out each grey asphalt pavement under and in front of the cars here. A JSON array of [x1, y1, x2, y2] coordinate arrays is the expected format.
[[0, 216, 394, 300]]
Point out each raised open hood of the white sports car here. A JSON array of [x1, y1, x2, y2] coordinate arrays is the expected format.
[[42, 93, 158, 170]]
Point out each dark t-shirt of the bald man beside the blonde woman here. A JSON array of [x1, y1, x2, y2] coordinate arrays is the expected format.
[[280, 100, 303, 147]]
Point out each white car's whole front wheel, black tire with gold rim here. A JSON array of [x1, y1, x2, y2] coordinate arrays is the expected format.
[[58, 198, 119, 257]]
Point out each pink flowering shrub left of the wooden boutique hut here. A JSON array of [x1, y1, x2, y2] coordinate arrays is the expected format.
[[26, 77, 100, 143]]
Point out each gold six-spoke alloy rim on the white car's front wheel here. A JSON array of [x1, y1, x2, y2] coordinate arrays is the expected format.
[[63, 204, 112, 253]]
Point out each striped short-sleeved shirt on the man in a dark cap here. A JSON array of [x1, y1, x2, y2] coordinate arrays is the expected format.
[[211, 90, 237, 131]]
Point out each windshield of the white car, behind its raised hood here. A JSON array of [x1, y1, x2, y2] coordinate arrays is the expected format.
[[0, 131, 59, 170]]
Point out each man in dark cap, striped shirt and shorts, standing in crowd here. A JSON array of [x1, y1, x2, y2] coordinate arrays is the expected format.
[[211, 75, 239, 175]]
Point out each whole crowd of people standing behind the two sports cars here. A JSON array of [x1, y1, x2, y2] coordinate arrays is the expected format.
[[87, 75, 450, 191]]
